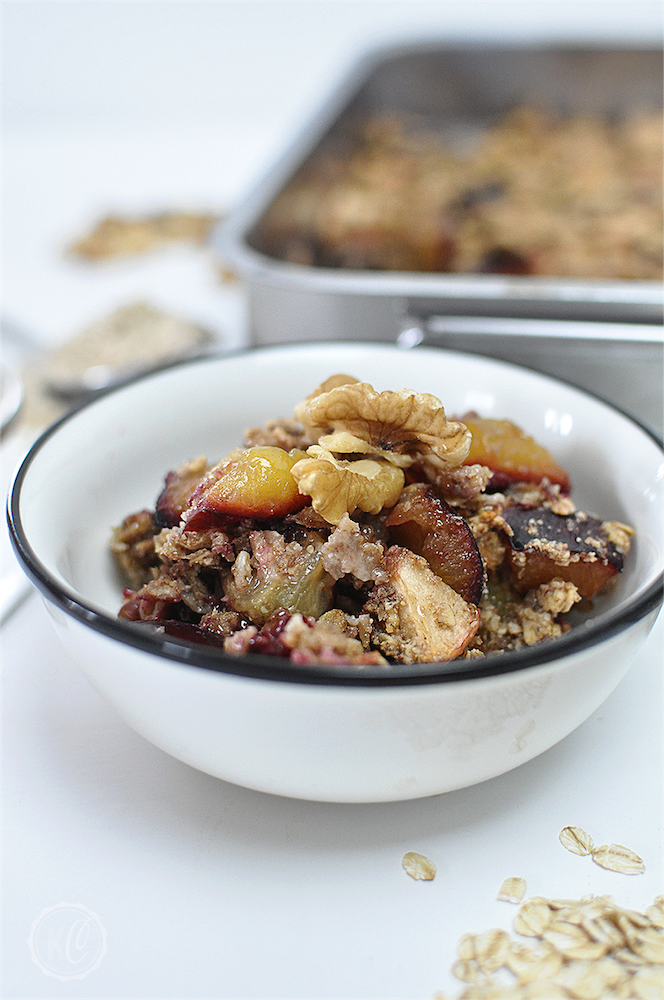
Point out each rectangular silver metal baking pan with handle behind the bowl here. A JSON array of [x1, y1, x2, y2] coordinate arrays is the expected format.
[[217, 45, 664, 437]]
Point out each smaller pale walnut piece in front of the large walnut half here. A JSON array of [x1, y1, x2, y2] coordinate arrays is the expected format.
[[290, 445, 404, 524]]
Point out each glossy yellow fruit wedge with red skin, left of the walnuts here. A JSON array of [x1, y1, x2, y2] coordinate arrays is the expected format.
[[183, 446, 309, 531]]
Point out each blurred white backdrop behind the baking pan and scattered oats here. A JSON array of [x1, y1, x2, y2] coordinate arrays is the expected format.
[[0, 0, 664, 343]]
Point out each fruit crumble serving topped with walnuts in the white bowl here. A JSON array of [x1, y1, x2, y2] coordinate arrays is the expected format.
[[111, 375, 633, 669]]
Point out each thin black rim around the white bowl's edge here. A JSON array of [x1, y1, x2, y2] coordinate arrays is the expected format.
[[7, 341, 664, 687]]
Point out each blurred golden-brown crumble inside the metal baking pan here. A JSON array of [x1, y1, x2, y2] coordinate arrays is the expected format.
[[250, 104, 664, 281]]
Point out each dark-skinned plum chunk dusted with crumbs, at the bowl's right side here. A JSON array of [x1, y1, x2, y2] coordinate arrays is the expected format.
[[503, 507, 623, 598]]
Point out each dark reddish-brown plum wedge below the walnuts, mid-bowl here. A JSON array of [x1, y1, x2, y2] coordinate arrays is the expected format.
[[385, 484, 484, 604]]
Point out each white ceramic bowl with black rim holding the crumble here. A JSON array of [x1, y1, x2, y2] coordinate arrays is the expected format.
[[9, 343, 664, 802]]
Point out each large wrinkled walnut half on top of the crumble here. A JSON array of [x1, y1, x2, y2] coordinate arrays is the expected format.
[[295, 380, 471, 468]]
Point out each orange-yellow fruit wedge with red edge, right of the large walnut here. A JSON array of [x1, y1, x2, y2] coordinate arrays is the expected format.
[[462, 416, 571, 493]]
